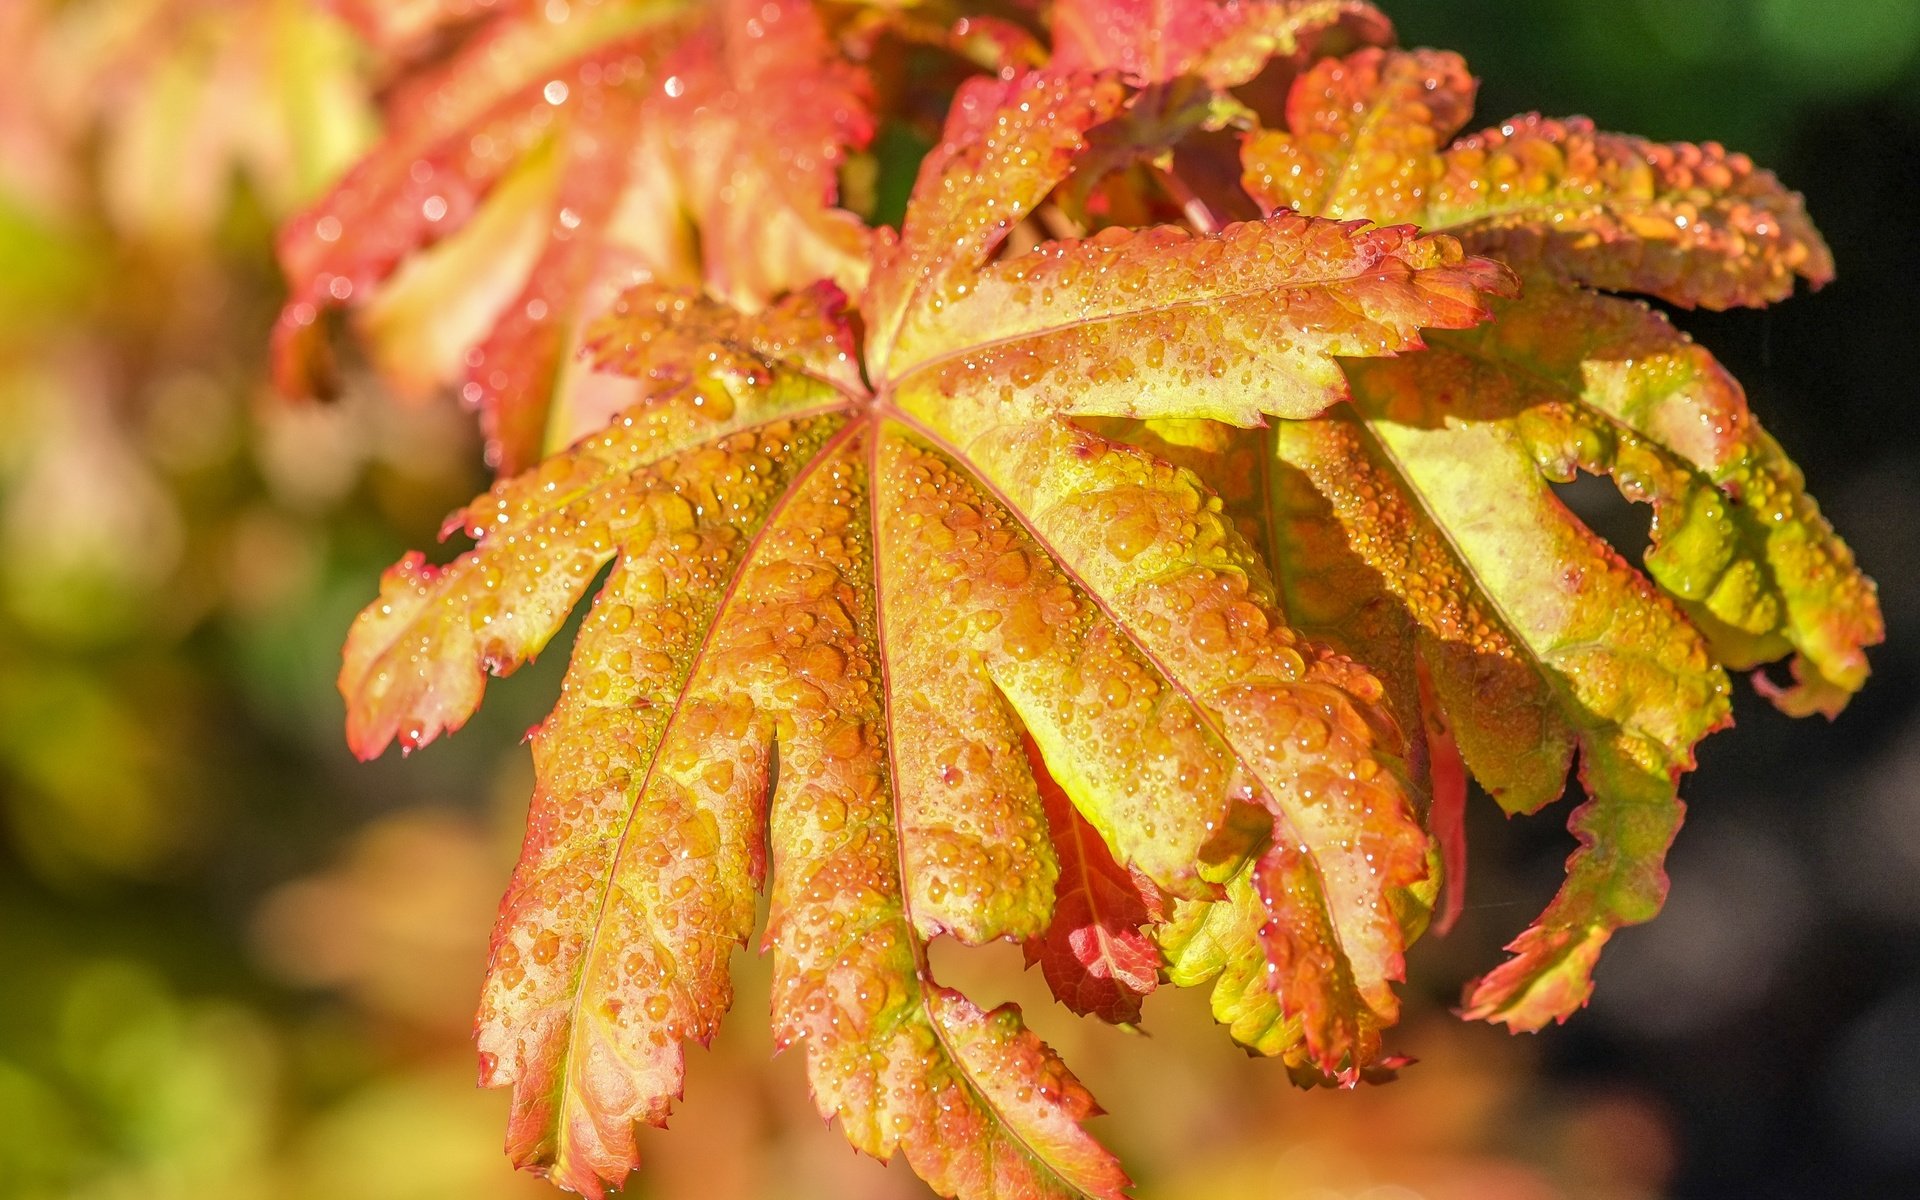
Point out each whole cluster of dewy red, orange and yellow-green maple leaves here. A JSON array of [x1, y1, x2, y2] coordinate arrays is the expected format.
[[291, 0, 1882, 1196]]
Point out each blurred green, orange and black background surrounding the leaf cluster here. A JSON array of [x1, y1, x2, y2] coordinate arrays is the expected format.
[[0, 0, 1920, 1200]]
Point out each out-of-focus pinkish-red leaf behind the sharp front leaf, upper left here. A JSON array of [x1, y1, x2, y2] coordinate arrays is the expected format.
[[276, 0, 872, 472]]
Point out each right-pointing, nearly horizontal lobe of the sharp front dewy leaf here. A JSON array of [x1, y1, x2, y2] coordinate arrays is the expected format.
[[891, 213, 1513, 424]]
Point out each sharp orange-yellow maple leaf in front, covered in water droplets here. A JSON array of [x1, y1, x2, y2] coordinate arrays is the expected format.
[[340, 73, 1509, 1196]]
